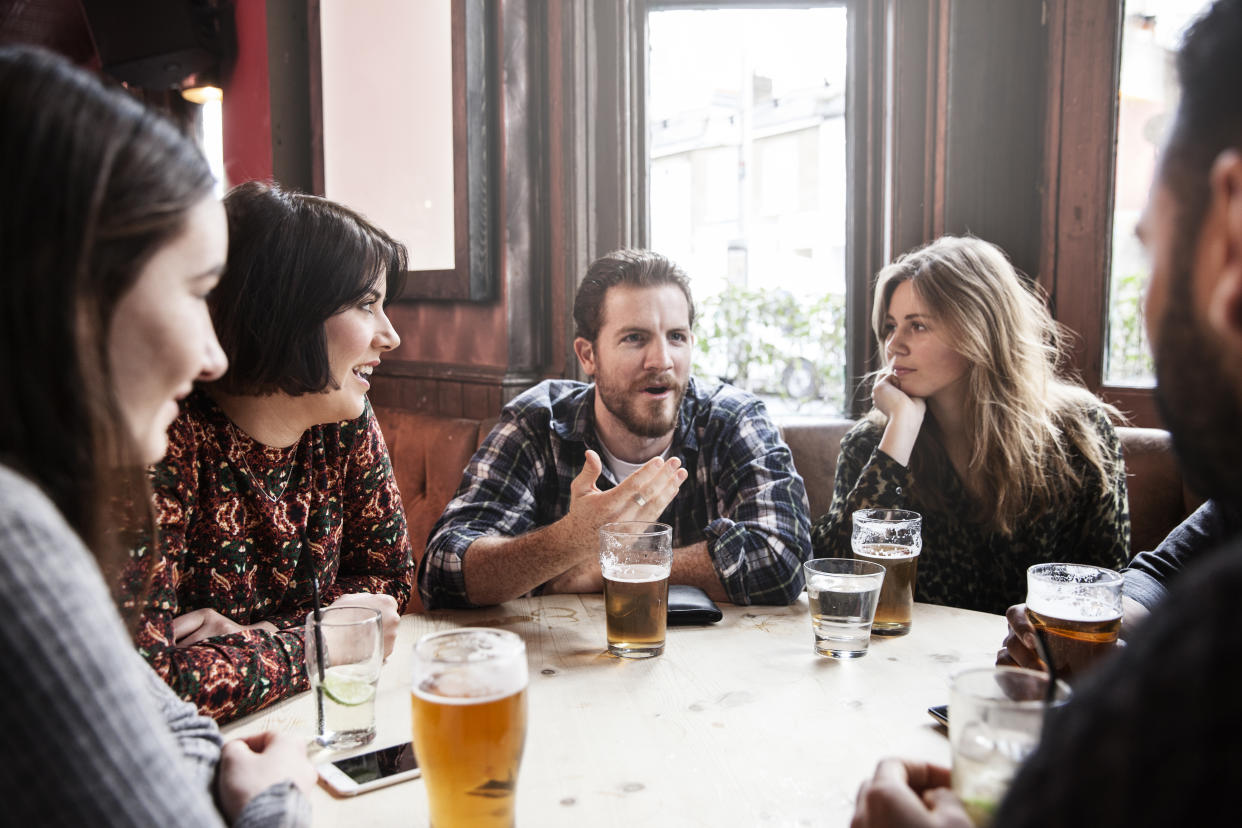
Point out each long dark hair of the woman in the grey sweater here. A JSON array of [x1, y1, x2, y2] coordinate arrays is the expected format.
[[0, 46, 214, 598]]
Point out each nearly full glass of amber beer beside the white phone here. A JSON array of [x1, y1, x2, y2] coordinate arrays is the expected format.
[[410, 627, 528, 828]]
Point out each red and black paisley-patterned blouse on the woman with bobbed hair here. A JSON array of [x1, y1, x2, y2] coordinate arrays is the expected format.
[[123, 391, 414, 721]]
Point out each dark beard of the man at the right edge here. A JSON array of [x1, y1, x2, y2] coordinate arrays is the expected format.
[[1155, 257, 1242, 506]]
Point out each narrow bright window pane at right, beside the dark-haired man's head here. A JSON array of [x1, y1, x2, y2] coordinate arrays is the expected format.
[[1104, 0, 1208, 387]]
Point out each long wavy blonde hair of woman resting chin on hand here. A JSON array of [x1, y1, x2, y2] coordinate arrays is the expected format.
[[867, 236, 1123, 536]]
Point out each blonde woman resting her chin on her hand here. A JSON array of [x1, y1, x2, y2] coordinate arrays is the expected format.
[[812, 237, 1130, 613]]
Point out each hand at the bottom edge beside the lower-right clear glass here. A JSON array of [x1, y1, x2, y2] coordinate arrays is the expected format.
[[850, 758, 971, 828]]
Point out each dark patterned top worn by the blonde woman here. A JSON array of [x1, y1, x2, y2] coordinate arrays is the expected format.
[[811, 411, 1130, 613]]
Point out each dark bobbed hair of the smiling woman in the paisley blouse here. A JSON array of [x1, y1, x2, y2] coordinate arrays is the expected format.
[[210, 181, 406, 396]]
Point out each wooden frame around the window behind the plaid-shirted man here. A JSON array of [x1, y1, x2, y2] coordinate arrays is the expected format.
[[576, 0, 929, 416]]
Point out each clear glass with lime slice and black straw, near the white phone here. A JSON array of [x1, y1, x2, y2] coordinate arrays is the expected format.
[[306, 607, 384, 749]]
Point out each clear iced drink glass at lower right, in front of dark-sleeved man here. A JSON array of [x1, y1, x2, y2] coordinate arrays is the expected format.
[[949, 667, 1069, 826]]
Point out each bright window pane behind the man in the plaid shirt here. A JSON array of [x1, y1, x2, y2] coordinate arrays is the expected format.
[[645, 4, 848, 413]]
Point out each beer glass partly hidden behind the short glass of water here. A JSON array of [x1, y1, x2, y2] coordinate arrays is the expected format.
[[850, 509, 923, 636]]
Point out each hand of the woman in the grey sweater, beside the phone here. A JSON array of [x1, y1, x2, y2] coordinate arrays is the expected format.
[[216, 731, 315, 823]]
